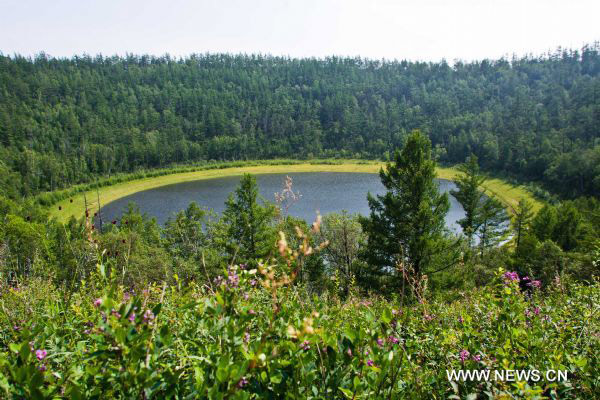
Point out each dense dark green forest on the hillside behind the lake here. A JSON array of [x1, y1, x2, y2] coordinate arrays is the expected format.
[[0, 43, 600, 198]]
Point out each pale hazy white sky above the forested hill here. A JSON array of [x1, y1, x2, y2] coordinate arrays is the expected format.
[[0, 0, 600, 61]]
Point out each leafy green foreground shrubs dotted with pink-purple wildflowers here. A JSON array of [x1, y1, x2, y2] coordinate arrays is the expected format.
[[0, 262, 600, 399]]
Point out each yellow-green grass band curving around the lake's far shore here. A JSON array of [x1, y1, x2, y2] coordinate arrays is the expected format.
[[50, 160, 541, 222]]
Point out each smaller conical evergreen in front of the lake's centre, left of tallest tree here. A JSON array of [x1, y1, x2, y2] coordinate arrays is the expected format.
[[223, 174, 276, 263]]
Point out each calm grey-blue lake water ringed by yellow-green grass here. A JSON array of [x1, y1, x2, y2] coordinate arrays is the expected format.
[[102, 172, 464, 232]]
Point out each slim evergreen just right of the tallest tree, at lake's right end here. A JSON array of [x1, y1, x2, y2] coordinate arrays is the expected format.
[[450, 155, 492, 246]]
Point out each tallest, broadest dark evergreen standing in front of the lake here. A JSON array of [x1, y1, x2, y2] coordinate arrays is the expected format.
[[360, 131, 450, 288]]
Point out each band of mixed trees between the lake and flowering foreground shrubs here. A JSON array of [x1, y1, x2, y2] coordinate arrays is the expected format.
[[0, 132, 600, 296]]
